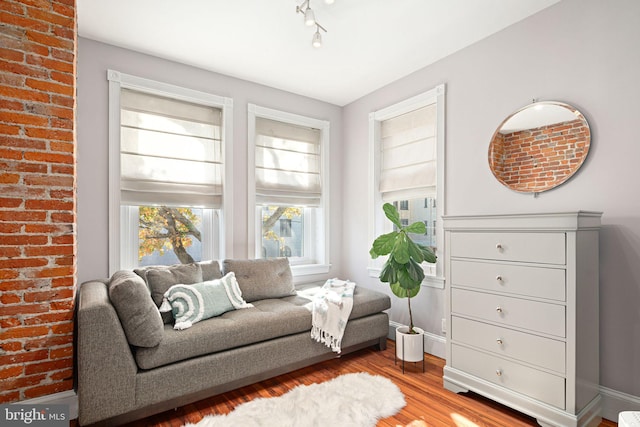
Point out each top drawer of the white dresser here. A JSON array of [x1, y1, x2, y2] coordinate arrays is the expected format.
[[449, 232, 566, 265]]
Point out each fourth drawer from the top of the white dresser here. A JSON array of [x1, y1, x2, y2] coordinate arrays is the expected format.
[[450, 316, 565, 374]]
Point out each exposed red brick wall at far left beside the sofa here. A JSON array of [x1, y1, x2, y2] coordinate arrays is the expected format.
[[0, 0, 77, 403]]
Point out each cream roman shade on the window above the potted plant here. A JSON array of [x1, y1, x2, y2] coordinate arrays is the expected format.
[[379, 104, 437, 202]]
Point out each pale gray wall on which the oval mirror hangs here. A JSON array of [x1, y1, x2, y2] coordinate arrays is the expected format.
[[342, 0, 640, 402]]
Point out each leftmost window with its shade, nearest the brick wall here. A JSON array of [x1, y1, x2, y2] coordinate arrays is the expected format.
[[108, 70, 231, 272]]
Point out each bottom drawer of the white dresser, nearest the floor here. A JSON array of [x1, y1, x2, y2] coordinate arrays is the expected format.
[[451, 344, 565, 409]]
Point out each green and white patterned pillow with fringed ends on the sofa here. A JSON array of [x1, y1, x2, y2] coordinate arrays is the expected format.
[[160, 272, 253, 330]]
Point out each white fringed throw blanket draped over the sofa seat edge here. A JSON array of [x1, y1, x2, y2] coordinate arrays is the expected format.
[[311, 279, 356, 353]]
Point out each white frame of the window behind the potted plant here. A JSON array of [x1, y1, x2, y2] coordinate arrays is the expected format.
[[367, 84, 446, 289]]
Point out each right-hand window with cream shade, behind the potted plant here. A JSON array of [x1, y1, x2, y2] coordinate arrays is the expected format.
[[369, 85, 445, 288]]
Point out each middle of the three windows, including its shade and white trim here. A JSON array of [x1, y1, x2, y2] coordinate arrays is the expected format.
[[248, 104, 329, 276]]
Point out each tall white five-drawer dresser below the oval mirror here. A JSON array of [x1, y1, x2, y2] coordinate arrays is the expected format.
[[444, 211, 601, 427]]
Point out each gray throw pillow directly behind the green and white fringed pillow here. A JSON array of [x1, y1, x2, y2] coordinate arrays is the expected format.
[[146, 263, 204, 323]]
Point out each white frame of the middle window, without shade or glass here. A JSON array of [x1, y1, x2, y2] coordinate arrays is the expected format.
[[247, 103, 331, 278]]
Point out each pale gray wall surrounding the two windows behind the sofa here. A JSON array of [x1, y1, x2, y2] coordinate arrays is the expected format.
[[77, 38, 342, 283]]
